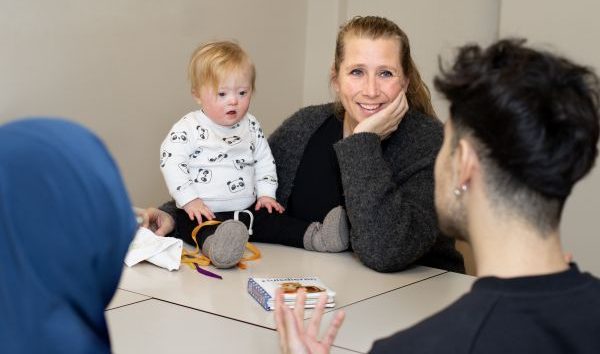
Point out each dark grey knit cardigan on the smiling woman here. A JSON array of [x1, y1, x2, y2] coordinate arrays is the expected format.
[[269, 104, 464, 272]]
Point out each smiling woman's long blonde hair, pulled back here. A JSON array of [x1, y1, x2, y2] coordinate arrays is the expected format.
[[332, 16, 437, 117]]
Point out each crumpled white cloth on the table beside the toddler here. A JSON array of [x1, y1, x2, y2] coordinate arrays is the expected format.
[[125, 227, 183, 270]]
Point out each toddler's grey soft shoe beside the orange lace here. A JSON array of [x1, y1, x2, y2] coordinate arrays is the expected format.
[[202, 220, 249, 268]]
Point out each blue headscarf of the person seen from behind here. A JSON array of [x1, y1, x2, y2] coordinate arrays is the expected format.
[[0, 119, 136, 353]]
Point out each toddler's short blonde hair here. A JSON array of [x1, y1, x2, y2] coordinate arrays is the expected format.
[[188, 41, 256, 93]]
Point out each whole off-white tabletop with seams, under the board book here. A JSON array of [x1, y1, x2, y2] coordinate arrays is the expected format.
[[107, 243, 473, 354]]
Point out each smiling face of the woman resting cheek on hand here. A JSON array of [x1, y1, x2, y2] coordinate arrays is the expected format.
[[332, 35, 408, 124]]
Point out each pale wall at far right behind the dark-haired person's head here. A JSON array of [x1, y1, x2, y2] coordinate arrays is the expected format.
[[500, 0, 600, 276]]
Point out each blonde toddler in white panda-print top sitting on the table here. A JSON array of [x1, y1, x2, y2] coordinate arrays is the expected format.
[[160, 41, 348, 268]]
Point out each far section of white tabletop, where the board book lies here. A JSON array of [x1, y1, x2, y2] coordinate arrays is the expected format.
[[119, 243, 445, 329]]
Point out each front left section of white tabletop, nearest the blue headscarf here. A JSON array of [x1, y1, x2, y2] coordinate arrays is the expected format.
[[106, 299, 352, 354]]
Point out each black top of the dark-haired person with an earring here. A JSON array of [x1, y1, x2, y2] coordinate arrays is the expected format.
[[372, 264, 600, 354]]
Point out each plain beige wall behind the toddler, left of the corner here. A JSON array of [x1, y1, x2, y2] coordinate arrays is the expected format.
[[0, 0, 306, 205]]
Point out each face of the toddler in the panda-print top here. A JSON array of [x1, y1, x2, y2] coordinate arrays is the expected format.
[[196, 70, 252, 126]]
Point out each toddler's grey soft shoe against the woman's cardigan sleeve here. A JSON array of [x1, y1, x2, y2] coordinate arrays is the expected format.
[[304, 205, 350, 252]]
